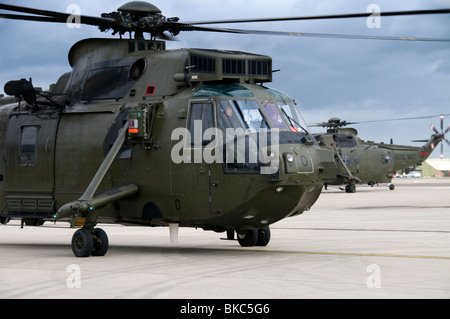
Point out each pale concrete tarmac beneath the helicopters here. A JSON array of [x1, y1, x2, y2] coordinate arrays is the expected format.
[[0, 178, 450, 299]]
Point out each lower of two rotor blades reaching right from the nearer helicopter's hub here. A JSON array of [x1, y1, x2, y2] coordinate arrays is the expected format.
[[175, 25, 450, 42]]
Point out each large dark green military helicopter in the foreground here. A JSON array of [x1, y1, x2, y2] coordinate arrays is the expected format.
[[0, 1, 450, 257]]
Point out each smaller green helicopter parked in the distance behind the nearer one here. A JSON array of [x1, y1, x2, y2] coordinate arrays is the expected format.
[[310, 116, 450, 193]]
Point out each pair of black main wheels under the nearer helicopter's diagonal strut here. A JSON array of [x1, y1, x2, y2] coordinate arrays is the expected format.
[[72, 228, 109, 257]]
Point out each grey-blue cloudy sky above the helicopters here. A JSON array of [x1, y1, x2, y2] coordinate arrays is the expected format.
[[0, 0, 450, 158]]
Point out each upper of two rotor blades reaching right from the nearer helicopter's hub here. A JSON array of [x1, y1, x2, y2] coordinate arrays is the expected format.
[[185, 9, 450, 25]]
